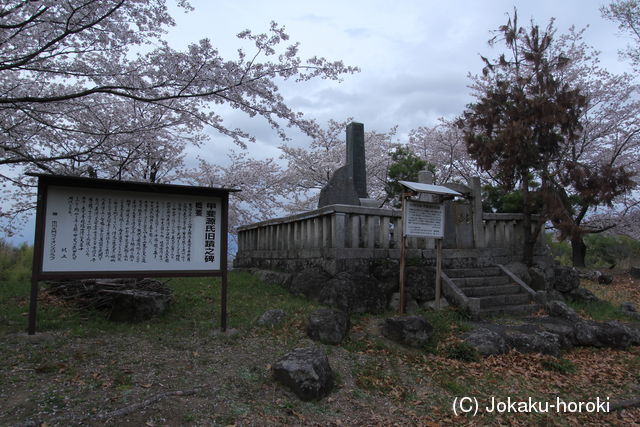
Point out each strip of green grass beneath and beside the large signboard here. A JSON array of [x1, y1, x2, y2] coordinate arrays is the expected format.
[[0, 272, 317, 338]]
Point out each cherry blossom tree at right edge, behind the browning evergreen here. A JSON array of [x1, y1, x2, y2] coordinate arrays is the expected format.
[[460, 11, 640, 266]]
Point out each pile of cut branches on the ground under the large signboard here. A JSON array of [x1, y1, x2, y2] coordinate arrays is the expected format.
[[46, 279, 171, 310]]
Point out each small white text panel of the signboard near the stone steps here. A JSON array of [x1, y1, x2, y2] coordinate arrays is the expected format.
[[403, 200, 444, 239]]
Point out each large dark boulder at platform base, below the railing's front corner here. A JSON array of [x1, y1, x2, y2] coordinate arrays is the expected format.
[[319, 271, 387, 313]]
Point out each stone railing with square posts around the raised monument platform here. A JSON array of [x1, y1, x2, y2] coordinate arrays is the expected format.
[[234, 205, 544, 272]]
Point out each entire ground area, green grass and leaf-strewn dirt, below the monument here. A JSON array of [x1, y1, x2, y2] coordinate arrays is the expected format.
[[0, 272, 640, 426]]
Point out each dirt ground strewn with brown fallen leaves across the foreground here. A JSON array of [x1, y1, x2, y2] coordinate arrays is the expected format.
[[0, 276, 640, 426]]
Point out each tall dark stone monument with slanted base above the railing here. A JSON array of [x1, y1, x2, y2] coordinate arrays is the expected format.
[[318, 122, 377, 208]]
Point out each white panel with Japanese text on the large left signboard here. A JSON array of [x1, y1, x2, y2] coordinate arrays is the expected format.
[[42, 185, 222, 272]]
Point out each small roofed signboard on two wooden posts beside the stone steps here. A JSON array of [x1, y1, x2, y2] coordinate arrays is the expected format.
[[399, 181, 461, 314]]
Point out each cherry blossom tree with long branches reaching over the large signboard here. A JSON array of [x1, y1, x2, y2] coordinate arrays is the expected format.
[[0, 0, 356, 234]]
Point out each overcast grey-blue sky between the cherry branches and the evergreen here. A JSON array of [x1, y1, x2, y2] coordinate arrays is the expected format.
[[169, 0, 629, 162]]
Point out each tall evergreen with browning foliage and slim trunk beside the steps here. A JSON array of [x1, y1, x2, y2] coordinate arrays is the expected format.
[[459, 11, 586, 264]]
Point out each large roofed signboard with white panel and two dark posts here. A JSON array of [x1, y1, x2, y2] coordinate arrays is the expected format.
[[28, 174, 239, 335]]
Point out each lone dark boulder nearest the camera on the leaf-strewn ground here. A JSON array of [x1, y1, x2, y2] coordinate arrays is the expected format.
[[273, 347, 334, 401]]
